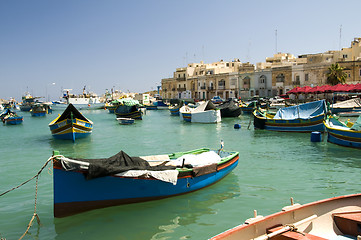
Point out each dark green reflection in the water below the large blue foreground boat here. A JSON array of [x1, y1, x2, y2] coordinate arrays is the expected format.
[[54, 173, 240, 239]]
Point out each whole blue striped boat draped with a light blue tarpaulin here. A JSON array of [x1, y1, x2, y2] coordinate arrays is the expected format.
[[253, 100, 327, 132]]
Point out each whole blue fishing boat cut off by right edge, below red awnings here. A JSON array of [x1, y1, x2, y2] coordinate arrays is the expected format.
[[324, 116, 361, 148]]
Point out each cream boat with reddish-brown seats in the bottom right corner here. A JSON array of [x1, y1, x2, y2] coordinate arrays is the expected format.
[[211, 194, 361, 240]]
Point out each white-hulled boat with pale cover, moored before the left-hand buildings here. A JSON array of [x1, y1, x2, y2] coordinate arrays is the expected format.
[[179, 101, 221, 123]]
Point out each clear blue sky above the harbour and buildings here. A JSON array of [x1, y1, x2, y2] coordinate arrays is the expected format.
[[0, 0, 361, 100]]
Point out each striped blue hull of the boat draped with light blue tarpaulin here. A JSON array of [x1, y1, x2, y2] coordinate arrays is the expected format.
[[253, 110, 325, 132]]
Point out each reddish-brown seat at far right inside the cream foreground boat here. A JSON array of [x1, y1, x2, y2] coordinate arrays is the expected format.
[[333, 212, 361, 237]]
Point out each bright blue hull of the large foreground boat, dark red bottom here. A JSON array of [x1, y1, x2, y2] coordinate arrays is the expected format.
[[53, 149, 239, 217]]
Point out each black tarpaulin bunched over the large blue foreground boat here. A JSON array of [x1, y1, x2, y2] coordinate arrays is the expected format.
[[75, 151, 176, 179]]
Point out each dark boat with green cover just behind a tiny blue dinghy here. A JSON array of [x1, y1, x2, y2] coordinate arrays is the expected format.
[[114, 98, 142, 119]]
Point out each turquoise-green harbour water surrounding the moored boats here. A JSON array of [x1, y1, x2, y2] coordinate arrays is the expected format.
[[0, 110, 361, 240]]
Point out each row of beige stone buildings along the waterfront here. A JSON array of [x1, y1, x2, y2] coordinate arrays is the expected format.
[[162, 38, 361, 100]]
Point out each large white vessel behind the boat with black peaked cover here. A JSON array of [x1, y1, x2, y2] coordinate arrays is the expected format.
[[52, 88, 105, 111]]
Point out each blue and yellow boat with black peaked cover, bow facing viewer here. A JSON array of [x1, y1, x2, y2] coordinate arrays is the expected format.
[[49, 104, 93, 141]]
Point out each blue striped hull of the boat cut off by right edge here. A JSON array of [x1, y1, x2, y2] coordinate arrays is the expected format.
[[324, 122, 361, 148]]
